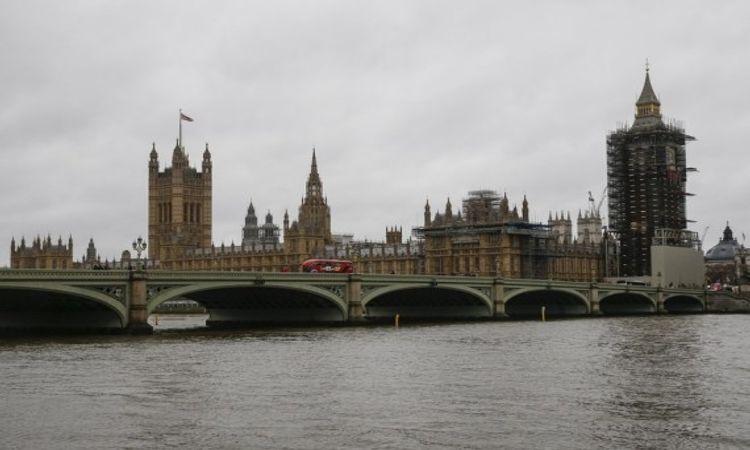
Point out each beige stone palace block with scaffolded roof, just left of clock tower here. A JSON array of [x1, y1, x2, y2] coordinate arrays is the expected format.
[[415, 190, 616, 281]]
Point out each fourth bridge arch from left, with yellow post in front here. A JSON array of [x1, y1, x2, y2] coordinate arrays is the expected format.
[[503, 287, 589, 318]]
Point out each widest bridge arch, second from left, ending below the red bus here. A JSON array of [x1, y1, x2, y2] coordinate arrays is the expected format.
[[147, 281, 349, 325]]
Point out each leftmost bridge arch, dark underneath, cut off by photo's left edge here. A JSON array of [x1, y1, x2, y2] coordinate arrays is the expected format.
[[0, 282, 128, 330]]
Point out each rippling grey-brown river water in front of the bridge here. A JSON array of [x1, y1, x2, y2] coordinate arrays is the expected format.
[[0, 315, 750, 449]]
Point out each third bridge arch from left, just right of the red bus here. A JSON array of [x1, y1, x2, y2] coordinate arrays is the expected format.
[[362, 283, 493, 320]]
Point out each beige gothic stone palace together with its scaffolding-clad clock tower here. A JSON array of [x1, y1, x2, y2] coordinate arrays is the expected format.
[[17, 68, 708, 281]]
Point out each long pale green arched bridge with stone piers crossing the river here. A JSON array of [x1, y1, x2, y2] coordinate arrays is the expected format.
[[0, 269, 711, 332]]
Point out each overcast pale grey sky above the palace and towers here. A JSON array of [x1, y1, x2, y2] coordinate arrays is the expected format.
[[0, 0, 750, 265]]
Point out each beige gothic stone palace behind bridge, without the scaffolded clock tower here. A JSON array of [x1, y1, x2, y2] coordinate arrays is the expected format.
[[11, 139, 616, 281]]
